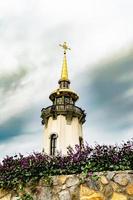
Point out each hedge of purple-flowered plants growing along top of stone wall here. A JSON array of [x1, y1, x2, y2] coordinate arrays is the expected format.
[[0, 140, 133, 191]]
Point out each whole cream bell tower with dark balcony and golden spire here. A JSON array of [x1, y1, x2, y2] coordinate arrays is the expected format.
[[41, 42, 86, 155]]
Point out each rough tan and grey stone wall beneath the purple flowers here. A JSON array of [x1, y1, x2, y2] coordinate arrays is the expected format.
[[0, 171, 133, 200]]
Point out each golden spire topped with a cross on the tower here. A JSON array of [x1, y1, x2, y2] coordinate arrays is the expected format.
[[59, 42, 71, 80]]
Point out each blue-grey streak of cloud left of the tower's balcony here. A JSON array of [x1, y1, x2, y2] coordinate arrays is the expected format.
[[0, 106, 41, 143]]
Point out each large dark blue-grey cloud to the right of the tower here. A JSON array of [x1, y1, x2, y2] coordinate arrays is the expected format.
[[81, 49, 133, 131]]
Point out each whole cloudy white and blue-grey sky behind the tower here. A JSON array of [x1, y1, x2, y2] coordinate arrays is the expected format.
[[0, 0, 133, 158]]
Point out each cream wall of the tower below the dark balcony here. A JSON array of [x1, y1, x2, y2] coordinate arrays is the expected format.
[[44, 115, 83, 154]]
